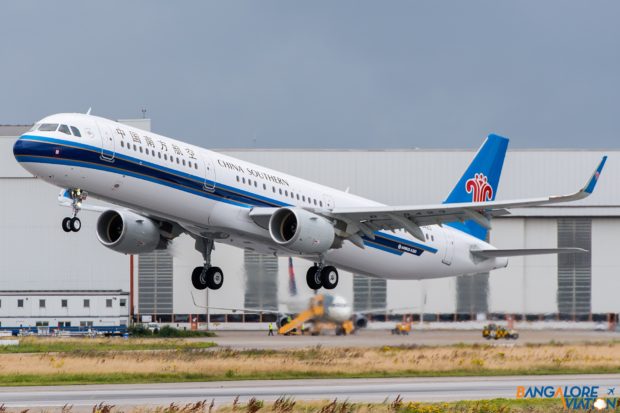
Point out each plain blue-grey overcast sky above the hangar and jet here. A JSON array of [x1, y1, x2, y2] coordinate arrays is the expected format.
[[0, 0, 620, 148]]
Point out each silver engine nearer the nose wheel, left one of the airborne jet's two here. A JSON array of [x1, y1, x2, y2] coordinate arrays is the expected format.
[[97, 209, 161, 254]]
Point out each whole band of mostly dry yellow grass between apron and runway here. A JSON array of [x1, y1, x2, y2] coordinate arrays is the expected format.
[[0, 338, 620, 386]]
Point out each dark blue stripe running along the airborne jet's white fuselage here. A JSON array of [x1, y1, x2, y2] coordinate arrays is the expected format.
[[13, 135, 437, 256]]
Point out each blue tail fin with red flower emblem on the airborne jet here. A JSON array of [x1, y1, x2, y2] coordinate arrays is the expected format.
[[444, 134, 508, 240]]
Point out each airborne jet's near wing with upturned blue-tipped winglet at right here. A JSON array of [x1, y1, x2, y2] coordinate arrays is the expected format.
[[324, 156, 607, 243]]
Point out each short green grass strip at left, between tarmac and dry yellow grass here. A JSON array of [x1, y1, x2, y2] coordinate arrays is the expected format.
[[0, 337, 216, 355]]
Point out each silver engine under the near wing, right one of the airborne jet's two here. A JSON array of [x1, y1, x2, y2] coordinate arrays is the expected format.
[[269, 208, 336, 254]]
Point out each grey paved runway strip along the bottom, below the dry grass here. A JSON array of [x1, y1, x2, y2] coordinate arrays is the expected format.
[[0, 374, 620, 410]]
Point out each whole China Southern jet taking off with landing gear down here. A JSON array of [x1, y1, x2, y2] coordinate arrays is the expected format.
[[13, 111, 607, 290]]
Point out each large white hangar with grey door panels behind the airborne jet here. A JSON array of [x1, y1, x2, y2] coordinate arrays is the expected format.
[[0, 120, 620, 326]]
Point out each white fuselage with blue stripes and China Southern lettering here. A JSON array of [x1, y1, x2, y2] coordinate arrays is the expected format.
[[14, 114, 507, 279]]
